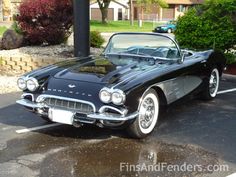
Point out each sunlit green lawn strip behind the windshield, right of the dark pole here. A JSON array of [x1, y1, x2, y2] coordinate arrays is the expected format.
[[90, 21, 160, 32]]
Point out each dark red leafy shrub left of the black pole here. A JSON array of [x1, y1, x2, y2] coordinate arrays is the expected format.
[[16, 0, 73, 45]]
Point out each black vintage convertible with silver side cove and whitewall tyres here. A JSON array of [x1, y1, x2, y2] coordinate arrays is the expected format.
[[17, 33, 226, 138]]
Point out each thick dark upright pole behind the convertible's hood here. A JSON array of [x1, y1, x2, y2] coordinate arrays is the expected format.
[[73, 0, 90, 57]]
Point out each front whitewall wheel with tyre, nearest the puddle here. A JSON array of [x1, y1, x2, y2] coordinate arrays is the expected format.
[[128, 89, 159, 138]]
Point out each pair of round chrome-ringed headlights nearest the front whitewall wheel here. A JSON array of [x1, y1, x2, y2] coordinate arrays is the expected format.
[[99, 87, 126, 105]]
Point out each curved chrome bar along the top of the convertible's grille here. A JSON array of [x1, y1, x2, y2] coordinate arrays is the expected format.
[[36, 94, 96, 112]]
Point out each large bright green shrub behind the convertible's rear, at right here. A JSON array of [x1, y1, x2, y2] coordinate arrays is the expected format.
[[175, 0, 236, 52]]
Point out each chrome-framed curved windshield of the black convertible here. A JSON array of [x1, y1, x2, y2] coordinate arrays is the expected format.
[[104, 33, 180, 60]]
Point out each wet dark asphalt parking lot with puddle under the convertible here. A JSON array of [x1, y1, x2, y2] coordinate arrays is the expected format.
[[0, 74, 236, 177]]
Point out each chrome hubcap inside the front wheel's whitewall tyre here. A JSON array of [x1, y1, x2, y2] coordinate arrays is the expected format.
[[140, 97, 155, 129]]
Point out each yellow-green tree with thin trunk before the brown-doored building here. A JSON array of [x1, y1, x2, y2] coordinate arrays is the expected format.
[[137, 0, 168, 19]]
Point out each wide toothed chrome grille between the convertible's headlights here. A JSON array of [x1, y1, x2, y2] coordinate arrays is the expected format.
[[44, 98, 94, 113]]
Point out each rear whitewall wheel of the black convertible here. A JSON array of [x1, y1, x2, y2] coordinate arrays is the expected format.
[[203, 68, 220, 100]]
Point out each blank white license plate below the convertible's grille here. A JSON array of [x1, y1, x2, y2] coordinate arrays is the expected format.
[[48, 108, 75, 125]]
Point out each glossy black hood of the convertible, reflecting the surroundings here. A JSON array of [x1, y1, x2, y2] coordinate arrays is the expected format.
[[54, 57, 156, 84]]
